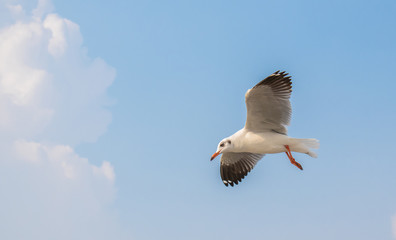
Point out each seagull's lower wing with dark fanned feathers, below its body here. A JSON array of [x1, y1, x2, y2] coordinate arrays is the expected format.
[[220, 152, 264, 187]]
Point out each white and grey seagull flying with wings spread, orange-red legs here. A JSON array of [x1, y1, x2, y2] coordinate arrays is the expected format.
[[210, 71, 319, 187]]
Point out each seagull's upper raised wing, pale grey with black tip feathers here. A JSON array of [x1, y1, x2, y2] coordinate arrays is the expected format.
[[245, 71, 292, 134]]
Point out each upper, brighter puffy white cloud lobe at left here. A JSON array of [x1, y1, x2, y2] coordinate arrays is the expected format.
[[0, 1, 115, 145]]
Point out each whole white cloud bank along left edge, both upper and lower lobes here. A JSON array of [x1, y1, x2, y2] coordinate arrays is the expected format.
[[0, 0, 122, 239]]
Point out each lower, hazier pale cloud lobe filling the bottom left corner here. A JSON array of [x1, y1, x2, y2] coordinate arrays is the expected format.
[[0, 143, 123, 240]]
